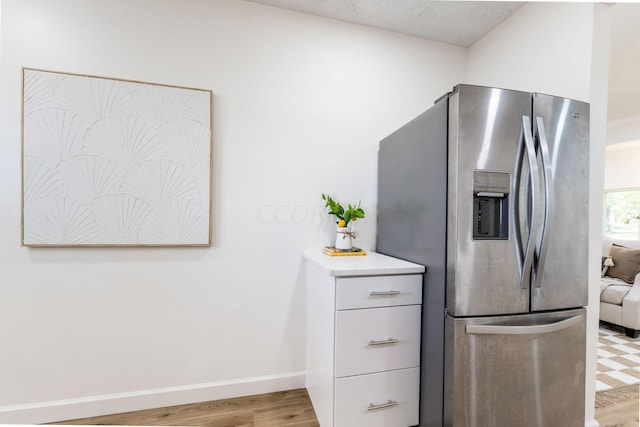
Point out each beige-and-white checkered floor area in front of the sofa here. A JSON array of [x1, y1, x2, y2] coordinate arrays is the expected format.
[[596, 324, 640, 391]]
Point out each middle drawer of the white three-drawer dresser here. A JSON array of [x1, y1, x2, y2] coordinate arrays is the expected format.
[[335, 305, 421, 377]]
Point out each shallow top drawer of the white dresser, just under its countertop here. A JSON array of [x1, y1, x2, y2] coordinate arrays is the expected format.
[[336, 274, 422, 310]]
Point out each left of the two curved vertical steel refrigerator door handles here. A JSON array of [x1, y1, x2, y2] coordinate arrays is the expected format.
[[514, 116, 540, 289]]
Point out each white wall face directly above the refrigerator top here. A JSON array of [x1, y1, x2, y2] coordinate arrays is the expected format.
[[468, 3, 593, 101]]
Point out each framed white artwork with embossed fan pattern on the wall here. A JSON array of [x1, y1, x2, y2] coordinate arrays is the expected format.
[[23, 69, 212, 246]]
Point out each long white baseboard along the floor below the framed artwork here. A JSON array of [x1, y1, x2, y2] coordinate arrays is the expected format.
[[0, 372, 305, 424]]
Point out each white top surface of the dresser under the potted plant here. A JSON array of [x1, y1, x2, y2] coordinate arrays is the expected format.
[[303, 249, 425, 277]]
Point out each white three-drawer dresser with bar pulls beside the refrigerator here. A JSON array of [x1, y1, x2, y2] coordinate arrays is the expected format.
[[304, 250, 425, 427]]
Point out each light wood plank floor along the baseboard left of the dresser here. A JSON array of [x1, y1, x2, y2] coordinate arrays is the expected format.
[[53, 389, 319, 427]]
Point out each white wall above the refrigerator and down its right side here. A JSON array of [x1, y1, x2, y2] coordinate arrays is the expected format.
[[468, 3, 610, 426]]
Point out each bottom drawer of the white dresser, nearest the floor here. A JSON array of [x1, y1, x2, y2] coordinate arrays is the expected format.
[[334, 368, 420, 427]]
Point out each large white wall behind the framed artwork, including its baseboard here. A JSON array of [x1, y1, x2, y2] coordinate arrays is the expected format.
[[0, 0, 466, 422]]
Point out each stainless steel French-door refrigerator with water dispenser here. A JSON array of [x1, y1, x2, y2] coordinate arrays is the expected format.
[[377, 85, 589, 427]]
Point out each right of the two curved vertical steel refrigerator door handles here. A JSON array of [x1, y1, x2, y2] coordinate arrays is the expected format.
[[534, 117, 553, 288]]
